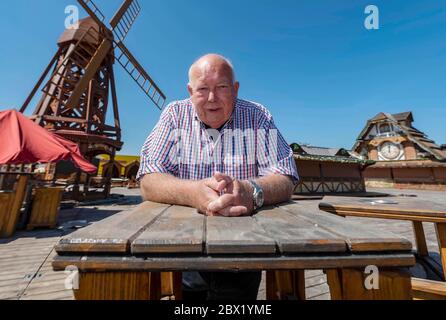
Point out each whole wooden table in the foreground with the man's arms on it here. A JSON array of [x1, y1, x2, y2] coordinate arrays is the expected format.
[[53, 202, 415, 299]]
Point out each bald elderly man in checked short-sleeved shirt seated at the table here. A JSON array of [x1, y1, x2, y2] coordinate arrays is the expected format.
[[138, 54, 298, 300]]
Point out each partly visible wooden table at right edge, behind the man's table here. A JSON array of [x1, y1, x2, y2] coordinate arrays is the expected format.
[[319, 197, 446, 297]]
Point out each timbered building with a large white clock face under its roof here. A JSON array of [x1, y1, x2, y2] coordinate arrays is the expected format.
[[352, 112, 446, 191]]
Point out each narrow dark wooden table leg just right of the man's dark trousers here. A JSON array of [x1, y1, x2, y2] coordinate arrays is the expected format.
[[266, 270, 305, 300]]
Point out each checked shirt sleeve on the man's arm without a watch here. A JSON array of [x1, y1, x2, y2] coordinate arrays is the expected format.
[[137, 106, 178, 180]]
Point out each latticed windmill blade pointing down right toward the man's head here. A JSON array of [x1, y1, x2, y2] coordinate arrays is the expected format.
[[114, 42, 166, 109]]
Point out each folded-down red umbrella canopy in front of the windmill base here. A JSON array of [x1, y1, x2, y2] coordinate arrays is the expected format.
[[0, 110, 97, 174]]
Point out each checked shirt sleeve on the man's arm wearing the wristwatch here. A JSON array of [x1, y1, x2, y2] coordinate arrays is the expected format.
[[257, 115, 299, 185]]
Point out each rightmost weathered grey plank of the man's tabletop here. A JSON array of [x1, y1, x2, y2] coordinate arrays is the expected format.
[[280, 202, 412, 252]]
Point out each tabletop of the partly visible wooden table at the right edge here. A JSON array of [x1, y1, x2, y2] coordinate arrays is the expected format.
[[319, 197, 446, 223]]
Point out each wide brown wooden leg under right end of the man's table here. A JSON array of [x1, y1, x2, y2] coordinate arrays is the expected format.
[[326, 268, 412, 300]]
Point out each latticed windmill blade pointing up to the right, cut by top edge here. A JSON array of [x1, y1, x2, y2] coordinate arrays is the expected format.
[[110, 0, 141, 42]]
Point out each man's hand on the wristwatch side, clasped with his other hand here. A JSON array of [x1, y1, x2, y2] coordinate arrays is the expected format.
[[206, 176, 254, 217]]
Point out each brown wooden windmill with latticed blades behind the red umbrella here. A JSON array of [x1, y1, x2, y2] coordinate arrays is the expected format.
[[20, 0, 166, 198]]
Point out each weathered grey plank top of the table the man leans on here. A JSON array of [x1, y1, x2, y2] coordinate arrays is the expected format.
[[53, 201, 415, 271]]
